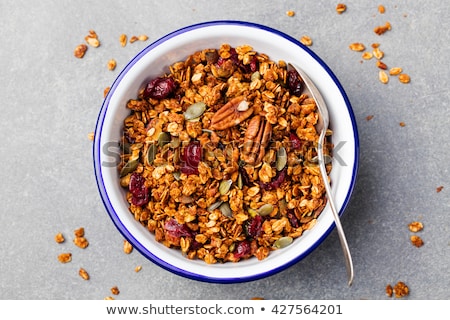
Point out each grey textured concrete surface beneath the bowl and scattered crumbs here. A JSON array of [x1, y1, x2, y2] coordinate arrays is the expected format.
[[0, 0, 450, 299]]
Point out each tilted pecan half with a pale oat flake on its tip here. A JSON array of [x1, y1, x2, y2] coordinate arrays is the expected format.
[[210, 97, 253, 130]]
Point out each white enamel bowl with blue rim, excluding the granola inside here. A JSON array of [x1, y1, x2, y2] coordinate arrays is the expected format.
[[93, 21, 359, 283]]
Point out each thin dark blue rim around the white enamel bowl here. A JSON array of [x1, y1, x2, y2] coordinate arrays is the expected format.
[[93, 20, 359, 283]]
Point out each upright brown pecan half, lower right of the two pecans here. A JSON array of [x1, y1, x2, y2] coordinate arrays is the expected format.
[[242, 115, 272, 165]]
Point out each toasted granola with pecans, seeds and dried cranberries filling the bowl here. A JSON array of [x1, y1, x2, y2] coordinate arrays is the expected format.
[[118, 44, 332, 264]]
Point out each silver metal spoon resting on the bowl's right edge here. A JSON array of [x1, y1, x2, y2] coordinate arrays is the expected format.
[[288, 63, 353, 286]]
